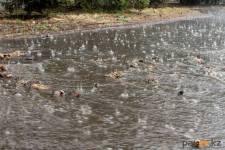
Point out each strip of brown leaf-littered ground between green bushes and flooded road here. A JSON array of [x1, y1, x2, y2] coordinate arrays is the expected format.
[[0, 4, 222, 38]]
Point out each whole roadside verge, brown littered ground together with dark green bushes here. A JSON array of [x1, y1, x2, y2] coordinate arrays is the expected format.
[[0, 0, 224, 38]]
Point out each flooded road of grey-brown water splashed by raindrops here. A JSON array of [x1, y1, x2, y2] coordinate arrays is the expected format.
[[0, 12, 225, 150]]
